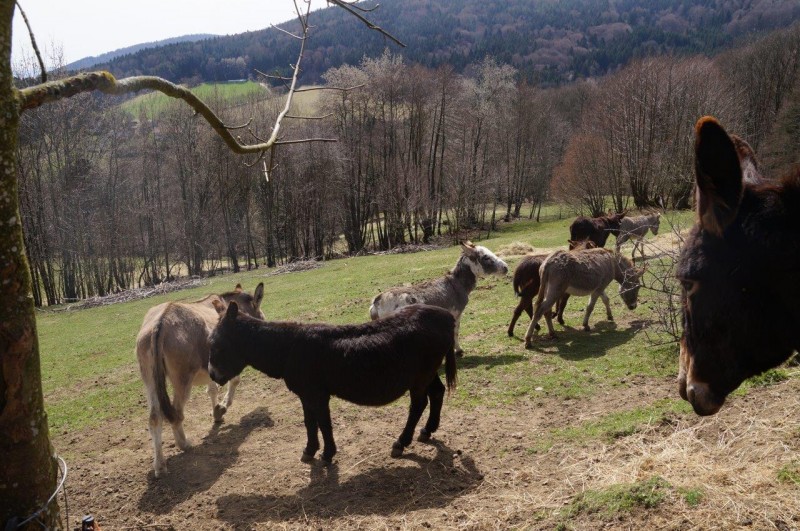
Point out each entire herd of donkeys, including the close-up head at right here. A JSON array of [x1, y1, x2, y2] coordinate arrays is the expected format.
[[136, 117, 800, 477]]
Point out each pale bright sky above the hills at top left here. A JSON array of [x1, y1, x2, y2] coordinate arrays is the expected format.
[[12, 0, 327, 66]]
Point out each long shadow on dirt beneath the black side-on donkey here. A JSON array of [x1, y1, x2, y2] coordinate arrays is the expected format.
[[212, 441, 483, 529]]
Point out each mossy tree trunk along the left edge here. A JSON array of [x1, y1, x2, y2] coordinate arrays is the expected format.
[[0, 0, 59, 529]]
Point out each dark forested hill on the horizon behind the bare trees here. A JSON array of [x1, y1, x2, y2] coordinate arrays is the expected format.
[[89, 0, 800, 83]]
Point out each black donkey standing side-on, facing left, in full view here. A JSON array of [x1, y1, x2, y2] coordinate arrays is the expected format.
[[208, 303, 456, 464]]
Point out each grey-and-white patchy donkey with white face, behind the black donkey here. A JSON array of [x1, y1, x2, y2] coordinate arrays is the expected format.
[[369, 241, 508, 357]]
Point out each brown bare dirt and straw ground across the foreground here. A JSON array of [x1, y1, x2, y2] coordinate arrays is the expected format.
[[54, 366, 800, 530]]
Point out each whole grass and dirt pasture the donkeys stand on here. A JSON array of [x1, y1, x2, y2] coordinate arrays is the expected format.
[[37, 213, 800, 529]]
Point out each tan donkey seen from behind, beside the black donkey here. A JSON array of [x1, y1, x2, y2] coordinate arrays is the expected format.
[[136, 282, 264, 477]]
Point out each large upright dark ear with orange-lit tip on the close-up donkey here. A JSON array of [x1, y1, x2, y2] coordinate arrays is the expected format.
[[694, 116, 742, 236]]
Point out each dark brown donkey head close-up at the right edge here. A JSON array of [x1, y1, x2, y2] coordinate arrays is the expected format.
[[677, 116, 800, 415]]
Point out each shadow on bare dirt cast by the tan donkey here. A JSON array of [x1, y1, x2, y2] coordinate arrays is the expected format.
[[139, 407, 273, 514]]
